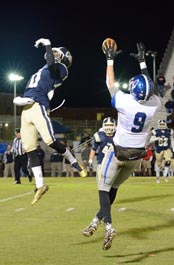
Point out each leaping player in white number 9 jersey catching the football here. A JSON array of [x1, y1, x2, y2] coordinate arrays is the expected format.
[[83, 38, 161, 250]]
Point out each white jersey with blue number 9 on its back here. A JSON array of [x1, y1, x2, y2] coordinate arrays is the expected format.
[[112, 90, 161, 148]]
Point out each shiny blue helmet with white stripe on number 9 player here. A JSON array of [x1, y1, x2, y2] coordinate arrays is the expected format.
[[129, 74, 154, 103]]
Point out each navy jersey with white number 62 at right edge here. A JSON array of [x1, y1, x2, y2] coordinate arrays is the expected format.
[[153, 129, 172, 153]]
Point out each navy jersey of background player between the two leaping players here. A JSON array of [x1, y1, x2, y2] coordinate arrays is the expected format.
[[92, 131, 114, 164]]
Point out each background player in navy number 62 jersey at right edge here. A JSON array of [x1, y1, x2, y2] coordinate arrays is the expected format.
[[150, 120, 174, 183]]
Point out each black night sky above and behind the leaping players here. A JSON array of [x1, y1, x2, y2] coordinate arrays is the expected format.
[[0, 1, 174, 107]]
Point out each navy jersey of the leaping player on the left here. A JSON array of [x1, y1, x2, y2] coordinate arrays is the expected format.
[[24, 63, 68, 109]]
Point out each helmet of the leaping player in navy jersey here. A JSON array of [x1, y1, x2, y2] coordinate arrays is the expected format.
[[44, 47, 72, 68]]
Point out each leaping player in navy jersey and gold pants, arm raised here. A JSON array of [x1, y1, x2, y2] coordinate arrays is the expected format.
[[13, 38, 87, 205]]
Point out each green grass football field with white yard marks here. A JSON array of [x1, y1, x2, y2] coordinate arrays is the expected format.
[[0, 177, 174, 265]]
